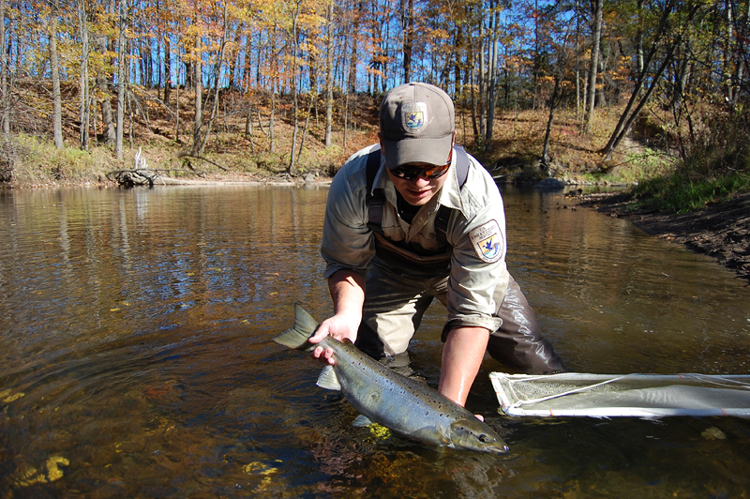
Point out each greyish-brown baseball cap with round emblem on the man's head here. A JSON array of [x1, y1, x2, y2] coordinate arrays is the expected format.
[[380, 83, 456, 169]]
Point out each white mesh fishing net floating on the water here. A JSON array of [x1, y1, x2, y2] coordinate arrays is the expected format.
[[490, 372, 750, 418]]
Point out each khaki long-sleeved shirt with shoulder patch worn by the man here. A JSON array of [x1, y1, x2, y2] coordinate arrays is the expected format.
[[321, 144, 509, 331]]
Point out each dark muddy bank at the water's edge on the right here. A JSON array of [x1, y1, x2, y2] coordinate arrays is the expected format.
[[580, 193, 750, 285]]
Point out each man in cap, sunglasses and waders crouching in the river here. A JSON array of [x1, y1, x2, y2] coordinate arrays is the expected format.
[[310, 83, 564, 406]]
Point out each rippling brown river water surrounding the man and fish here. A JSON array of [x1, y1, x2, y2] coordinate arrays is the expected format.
[[0, 187, 750, 498]]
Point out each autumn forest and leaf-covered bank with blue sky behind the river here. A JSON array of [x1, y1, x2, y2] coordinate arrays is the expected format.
[[0, 0, 750, 199]]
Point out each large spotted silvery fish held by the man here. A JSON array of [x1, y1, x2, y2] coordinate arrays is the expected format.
[[274, 304, 508, 454]]
